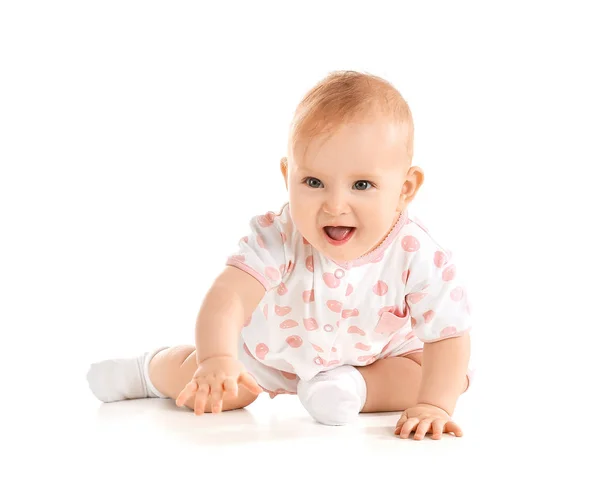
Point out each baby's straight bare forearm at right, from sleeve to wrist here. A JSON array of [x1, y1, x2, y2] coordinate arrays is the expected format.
[[418, 332, 471, 416]]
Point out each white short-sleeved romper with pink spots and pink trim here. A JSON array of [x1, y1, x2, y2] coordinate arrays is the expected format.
[[226, 203, 471, 397]]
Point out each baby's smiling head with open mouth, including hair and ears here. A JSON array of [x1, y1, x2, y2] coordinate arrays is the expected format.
[[281, 71, 423, 261]]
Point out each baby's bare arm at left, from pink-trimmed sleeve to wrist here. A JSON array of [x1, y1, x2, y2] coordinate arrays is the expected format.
[[196, 266, 265, 364]]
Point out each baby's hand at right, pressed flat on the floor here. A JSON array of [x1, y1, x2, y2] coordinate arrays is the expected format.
[[394, 404, 462, 440]]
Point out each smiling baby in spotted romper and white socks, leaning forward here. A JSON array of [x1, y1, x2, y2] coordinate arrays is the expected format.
[[87, 71, 471, 439]]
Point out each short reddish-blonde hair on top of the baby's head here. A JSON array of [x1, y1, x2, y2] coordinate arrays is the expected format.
[[288, 71, 414, 162]]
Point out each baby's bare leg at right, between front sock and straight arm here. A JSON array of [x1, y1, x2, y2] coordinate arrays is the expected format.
[[357, 351, 469, 413]]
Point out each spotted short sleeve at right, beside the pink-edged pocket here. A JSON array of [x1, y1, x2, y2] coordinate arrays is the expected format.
[[406, 238, 471, 343]]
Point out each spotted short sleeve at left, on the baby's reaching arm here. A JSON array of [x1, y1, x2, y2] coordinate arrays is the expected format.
[[226, 212, 290, 291]]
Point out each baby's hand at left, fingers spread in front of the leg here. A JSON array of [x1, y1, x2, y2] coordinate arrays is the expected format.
[[175, 356, 262, 415]]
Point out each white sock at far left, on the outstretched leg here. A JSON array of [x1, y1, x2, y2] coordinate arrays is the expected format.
[[87, 347, 167, 403]]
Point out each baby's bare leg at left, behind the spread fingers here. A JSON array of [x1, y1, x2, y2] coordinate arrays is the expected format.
[[148, 345, 258, 413]]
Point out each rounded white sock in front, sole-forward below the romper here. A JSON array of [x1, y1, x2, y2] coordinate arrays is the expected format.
[[297, 365, 367, 425]]
